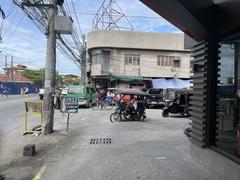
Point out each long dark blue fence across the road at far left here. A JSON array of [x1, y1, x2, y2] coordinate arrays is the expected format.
[[0, 81, 38, 95]]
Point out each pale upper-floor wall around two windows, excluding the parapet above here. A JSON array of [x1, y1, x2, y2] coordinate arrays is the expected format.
[[100, 49, 190, 78]]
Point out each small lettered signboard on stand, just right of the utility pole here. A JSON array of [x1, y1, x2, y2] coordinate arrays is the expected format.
[[61, 97, 78, 113]]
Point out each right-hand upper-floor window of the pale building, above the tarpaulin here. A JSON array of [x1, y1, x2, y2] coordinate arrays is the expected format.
[[157, 56, 181, 67]]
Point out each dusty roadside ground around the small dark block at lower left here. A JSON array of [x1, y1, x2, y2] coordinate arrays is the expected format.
[[0, 113, 65, 180]]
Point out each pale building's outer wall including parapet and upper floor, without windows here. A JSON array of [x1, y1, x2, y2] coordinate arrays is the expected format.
[[87, 30, 190, 78]]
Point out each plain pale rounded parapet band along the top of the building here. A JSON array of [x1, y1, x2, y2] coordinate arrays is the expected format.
[[87, 30, 185, 51]]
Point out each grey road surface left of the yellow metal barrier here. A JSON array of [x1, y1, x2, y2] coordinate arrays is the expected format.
[[0, 95, 38, 136]]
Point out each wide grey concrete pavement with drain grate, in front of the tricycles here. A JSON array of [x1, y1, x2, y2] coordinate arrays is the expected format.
[[0, 109, 224, 180]]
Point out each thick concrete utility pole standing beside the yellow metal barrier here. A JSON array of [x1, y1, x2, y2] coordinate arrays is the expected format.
[[42, 0, 57, 135]]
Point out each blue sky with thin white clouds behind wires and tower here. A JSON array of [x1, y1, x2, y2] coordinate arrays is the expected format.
[[0, 0, 181, 75]]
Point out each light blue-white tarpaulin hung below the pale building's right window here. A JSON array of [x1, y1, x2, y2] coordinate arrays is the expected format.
[[152, 77, 191, 89]]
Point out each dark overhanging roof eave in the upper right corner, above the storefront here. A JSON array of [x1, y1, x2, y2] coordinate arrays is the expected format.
[[140, 0, 240, 41]]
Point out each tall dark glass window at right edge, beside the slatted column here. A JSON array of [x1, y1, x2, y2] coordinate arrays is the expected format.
[[215, 42, 240, 158]]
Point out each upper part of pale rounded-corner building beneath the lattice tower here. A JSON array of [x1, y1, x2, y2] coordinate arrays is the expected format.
[[87, 30, 190, 88]]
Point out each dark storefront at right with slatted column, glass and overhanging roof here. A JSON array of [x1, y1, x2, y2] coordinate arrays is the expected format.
[[141, 0, 240, 180]]
